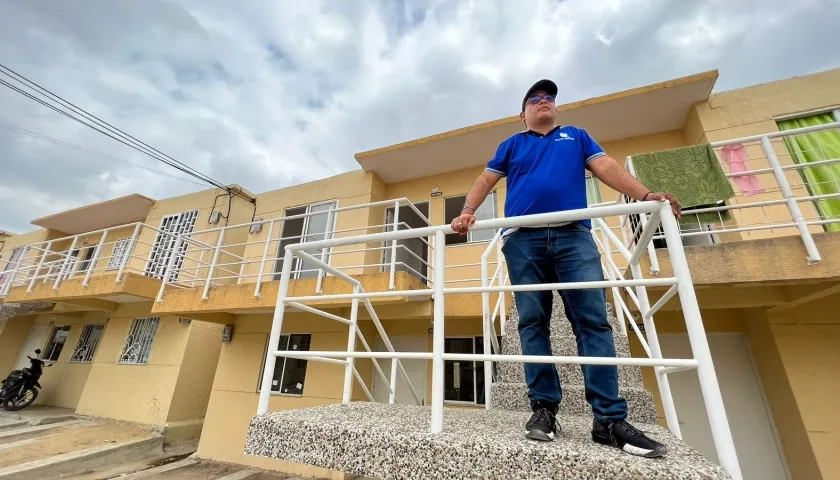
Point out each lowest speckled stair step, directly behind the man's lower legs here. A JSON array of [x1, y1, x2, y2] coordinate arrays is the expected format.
[[493, 383, 657, 423]]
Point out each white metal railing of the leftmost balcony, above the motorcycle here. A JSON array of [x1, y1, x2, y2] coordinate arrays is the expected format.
[[0, 222, 194, 298]]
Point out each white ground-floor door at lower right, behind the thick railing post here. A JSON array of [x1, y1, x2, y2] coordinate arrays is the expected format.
[[659, 334, 788, 480]]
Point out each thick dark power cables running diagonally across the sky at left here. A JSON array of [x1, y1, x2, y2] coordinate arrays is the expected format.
[[0, 64, 254, 201]]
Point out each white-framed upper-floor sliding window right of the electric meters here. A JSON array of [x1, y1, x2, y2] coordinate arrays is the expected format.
[[274, 201, 337, 280]]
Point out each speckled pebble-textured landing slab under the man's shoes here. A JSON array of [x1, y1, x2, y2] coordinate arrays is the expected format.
[[245, 402, 729, 480]]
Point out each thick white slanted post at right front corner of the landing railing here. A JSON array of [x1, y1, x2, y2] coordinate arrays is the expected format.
[[664, 204, 742, 480]]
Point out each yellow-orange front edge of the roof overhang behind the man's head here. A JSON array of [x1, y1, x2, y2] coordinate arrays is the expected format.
[[354, 69, 720, 160]]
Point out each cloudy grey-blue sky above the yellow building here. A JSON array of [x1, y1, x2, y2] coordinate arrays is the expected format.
[[0, 0, 840, 232]]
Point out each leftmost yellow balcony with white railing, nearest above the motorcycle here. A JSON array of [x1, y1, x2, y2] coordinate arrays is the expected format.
[[0, 223, 184, 310]]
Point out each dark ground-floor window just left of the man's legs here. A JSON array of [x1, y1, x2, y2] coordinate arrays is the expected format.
[[443, 337, 502, 405]]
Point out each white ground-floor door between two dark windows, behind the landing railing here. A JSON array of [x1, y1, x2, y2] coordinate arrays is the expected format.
[[373, 336, 426, 405]]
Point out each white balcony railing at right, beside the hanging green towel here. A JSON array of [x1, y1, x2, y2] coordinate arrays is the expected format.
[[618, 122, 840, 272]]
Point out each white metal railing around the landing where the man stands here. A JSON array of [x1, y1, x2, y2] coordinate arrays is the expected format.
[[257, 201, 741, 480]]
